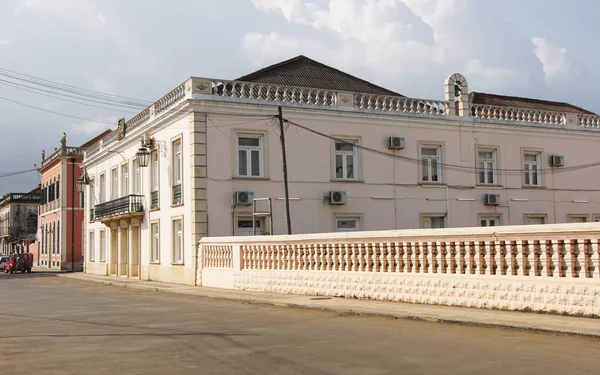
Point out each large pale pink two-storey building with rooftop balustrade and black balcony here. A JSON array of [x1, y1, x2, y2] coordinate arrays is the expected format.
[[84, 56, 600, 284]]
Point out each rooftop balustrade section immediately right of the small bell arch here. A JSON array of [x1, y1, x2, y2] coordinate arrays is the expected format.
[[471, 104, 566, 125]]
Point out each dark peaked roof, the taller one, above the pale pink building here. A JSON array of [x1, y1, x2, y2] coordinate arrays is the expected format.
[[237, 55, 403, 96]]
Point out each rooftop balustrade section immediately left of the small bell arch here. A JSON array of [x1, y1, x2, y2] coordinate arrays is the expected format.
[[354, 94, 446, 116]]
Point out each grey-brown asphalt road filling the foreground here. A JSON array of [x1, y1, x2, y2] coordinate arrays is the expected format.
[[0, 273, 600, 375]]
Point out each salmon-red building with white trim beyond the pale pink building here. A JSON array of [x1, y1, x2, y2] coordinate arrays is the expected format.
[[37, 131, 108, 271]]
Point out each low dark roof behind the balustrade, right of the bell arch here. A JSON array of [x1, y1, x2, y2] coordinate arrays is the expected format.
[[469, 92, 595, 115]]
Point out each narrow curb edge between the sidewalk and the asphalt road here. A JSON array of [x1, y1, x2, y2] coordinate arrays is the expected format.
[[56, 273, 600, 339]]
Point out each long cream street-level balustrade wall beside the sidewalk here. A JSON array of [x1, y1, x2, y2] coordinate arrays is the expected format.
[[198, 223, 600, 315]]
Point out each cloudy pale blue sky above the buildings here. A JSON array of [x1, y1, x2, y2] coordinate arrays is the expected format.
[[0, 0, 600, 194]]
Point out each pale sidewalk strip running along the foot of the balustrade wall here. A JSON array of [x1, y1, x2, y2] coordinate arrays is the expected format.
[[56, 273, 600, 338]]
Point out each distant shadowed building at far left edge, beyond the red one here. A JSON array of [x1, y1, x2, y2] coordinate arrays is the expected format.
[[0, 187, 40, 261]]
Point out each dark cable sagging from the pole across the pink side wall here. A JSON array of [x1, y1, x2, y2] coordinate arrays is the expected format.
[[284, 120, 600, 175]]
